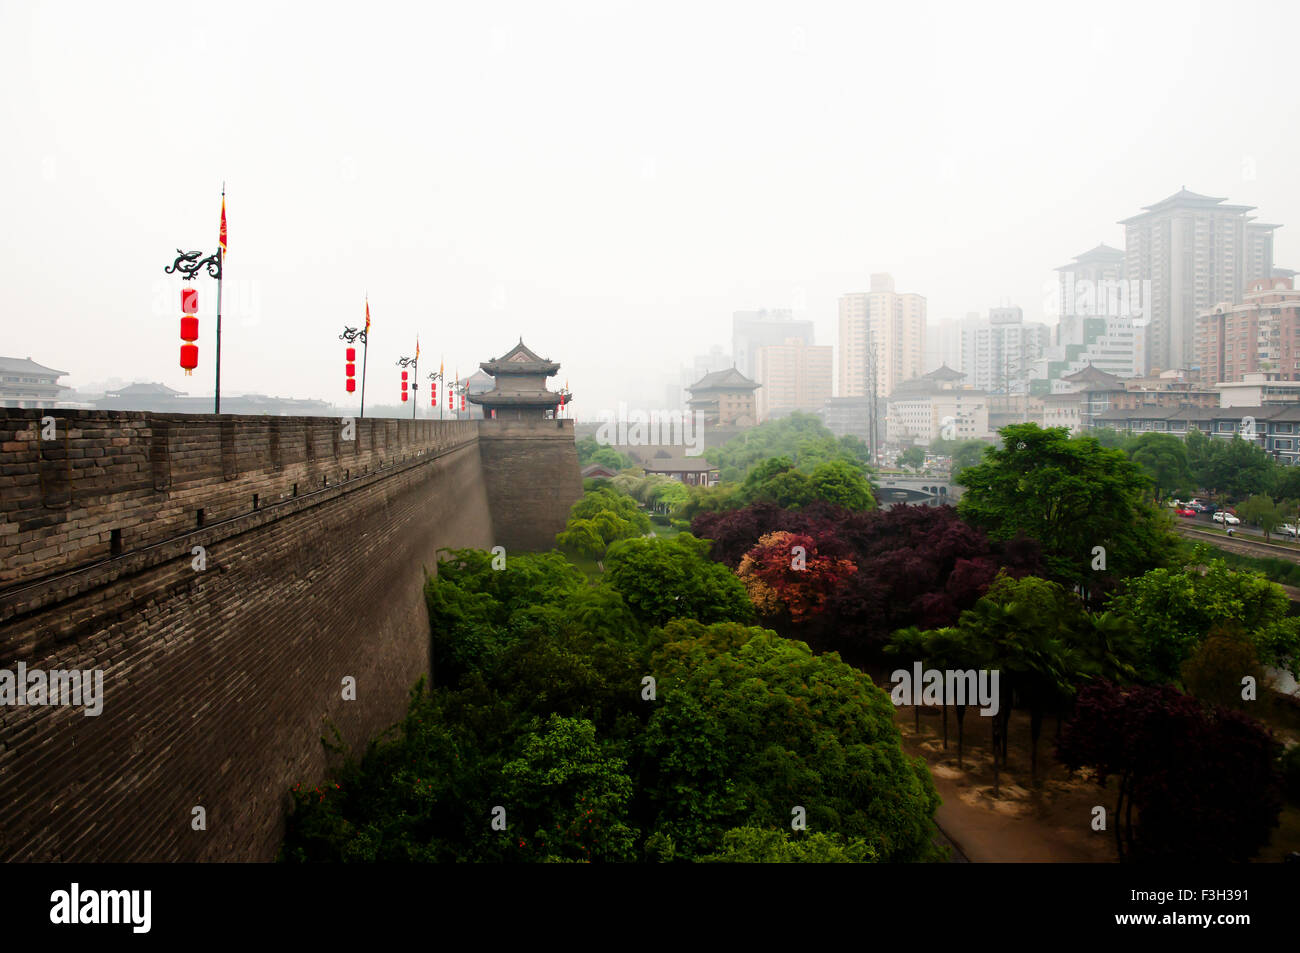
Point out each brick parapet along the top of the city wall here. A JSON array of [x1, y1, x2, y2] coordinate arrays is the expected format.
[[0, 408, 477, 595]]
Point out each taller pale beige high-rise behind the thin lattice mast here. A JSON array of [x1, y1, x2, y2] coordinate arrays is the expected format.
[[839, 274, 926, 397]]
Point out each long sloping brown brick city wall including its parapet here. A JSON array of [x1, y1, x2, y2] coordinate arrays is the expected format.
[[0, 410, 504, 861]]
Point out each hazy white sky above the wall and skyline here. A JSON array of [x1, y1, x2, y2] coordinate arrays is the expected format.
[[0, 0, 1300, 416]]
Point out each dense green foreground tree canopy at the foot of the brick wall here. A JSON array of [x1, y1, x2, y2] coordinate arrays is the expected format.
[[282, 536, 939, 862]]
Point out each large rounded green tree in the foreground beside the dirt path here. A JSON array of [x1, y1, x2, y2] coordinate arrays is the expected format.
[[644, 621, 939, 861]]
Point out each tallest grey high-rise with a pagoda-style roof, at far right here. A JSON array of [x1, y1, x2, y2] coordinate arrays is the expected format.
[[1119, 189, 1278, 373]]
